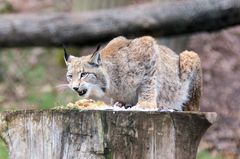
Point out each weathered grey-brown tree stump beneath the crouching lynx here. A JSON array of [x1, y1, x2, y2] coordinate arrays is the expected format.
[[0, 109, 216, 159]]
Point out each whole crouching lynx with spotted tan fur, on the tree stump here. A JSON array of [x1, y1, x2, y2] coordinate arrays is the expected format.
[[64, 36, 202, 111]]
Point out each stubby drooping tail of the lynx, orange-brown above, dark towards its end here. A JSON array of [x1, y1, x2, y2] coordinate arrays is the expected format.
[[179, 51, 202, 111]]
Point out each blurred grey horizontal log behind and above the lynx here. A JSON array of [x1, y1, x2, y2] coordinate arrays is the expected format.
[[0, 0, 240, 47]]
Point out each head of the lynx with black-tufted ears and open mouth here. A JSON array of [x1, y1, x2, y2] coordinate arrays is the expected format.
[[64, 46, 107, 99]]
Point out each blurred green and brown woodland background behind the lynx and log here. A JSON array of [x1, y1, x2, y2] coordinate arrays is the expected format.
[[0, 0, 240, 159]]
